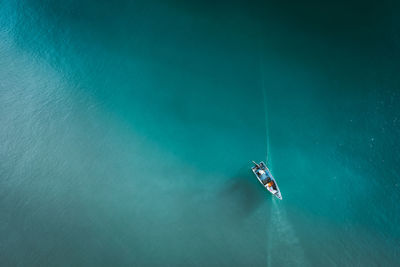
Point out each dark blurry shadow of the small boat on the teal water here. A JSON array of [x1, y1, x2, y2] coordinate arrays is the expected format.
[[219, 167, 266, 220]]
